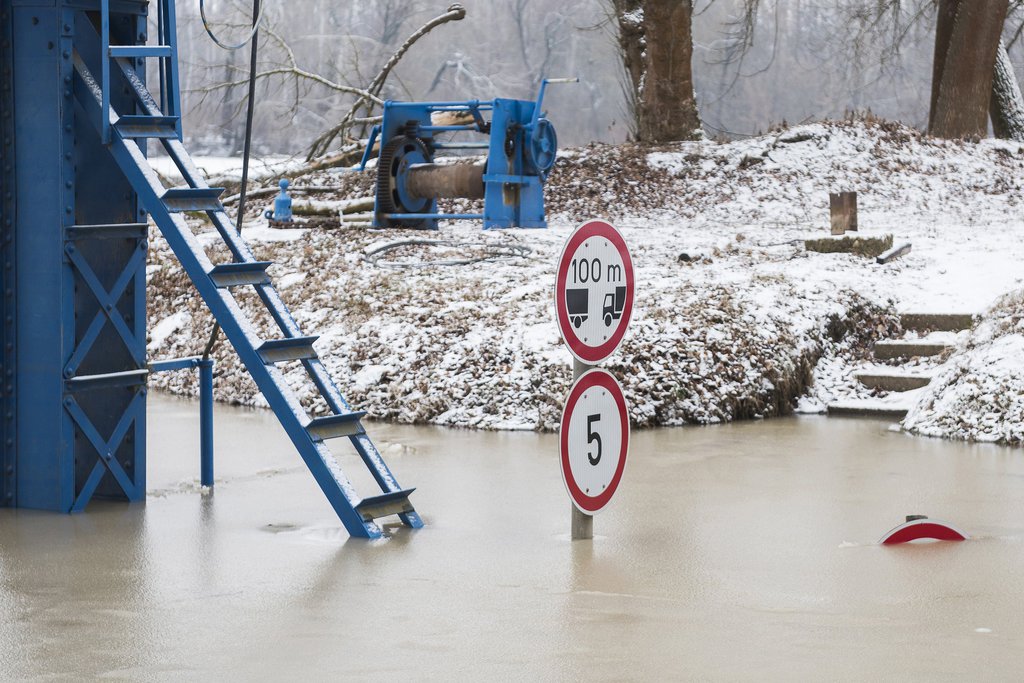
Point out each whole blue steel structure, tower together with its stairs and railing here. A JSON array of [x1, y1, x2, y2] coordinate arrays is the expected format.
[[0, 0, 422, 538]]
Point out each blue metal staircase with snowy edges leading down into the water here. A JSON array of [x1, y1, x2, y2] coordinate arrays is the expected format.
[[73, 0, 423, 538]]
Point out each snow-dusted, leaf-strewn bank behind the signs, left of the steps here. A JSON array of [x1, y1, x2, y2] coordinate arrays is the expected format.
[[150, 122, 1024, 438]]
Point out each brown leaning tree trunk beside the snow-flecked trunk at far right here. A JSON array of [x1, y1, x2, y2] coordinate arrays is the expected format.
[[929, 0, 1009, 138]]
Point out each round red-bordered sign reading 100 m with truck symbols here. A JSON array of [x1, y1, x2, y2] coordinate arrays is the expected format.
[[555, 220, 634, 366]]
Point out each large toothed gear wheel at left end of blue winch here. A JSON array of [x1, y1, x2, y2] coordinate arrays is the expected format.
[[377, 135, 433, 227]]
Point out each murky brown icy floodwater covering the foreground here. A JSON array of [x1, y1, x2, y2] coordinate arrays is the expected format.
[[0, 394, 1024, 680]]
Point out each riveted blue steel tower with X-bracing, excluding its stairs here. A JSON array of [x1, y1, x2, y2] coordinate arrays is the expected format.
[[0, 0, 146, 512]]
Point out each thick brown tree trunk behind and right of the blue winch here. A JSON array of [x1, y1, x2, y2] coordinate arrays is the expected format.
[[614, 0, 700, 142]]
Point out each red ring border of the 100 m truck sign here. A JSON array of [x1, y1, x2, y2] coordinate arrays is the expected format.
[[555, 220, 635, 366]]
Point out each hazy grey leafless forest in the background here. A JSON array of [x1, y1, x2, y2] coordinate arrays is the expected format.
[[178, 0, 1024, 155]]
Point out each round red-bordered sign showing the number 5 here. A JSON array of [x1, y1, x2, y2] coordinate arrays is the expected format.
[[559, 369, 630, 515]]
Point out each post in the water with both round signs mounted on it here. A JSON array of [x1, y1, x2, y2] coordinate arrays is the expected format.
[[555, 220, 634, 541]]
